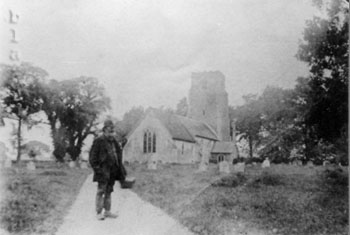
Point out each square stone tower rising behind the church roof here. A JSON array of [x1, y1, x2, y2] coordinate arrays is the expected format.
[[187, 71, 230, 141]]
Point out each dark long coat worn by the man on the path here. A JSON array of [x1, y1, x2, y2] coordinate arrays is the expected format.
[[89, 135, 126, 182]]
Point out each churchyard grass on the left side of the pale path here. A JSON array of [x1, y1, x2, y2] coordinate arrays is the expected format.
[[0, 162, 91, 235]]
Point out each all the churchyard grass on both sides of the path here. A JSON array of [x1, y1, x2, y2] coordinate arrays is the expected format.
[[0, 161, 349, 235]]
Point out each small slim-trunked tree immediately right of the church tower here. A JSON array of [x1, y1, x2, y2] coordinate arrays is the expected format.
[[231, 94, 262, 157]]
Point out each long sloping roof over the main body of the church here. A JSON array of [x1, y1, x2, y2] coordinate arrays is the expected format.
[[154, 109, 218, 143]]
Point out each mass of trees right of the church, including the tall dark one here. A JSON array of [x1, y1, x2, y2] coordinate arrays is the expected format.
[[230, 0, 349, 164]]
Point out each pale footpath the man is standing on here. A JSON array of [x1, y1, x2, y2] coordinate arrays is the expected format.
[[56, 175, 193, 235]]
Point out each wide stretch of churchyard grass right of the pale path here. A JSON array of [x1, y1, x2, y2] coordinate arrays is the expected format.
[[127, 164, 349, 235]]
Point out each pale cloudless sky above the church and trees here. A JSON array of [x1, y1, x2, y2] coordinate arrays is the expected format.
[[0, 0, 317, 118]]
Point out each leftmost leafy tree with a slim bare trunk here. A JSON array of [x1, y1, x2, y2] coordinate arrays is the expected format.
[[1, 63, 48, 162]]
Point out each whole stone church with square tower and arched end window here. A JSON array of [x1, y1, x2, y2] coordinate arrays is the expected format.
[[123, 71, 237, 163]]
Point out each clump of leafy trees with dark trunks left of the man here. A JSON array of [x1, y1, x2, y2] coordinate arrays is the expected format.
[[1, 63, 110, 160]]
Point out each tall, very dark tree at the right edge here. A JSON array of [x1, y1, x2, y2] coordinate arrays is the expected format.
[[297, 0, 349, 143]]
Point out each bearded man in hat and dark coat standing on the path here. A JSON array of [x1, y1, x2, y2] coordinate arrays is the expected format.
[[89, 120, 126, 220]]
